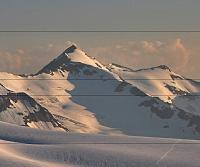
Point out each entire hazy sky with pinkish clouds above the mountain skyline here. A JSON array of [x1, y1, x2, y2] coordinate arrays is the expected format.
[[0, 0, 200, 78]]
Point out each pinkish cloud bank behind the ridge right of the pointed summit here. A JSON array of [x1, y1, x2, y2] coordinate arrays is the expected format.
[[89, 38, 191, 73]]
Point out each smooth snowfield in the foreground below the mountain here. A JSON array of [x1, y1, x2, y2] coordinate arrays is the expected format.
[[0, 122, 200, 167]]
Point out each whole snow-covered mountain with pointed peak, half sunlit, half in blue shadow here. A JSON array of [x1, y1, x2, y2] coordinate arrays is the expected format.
[[0, 45, 200, 139]]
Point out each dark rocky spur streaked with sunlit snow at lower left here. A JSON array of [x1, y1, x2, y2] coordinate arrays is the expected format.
[[0, 85, 67, 130]]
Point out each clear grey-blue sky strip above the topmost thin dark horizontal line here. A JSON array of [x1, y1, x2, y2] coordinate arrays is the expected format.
[[0, 0, 200, 30]]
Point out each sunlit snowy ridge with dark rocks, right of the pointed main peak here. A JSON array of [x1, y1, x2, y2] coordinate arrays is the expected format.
[[108, 64, 200, 103]]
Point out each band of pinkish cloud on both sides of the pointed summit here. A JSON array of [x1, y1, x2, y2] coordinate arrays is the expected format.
[[0, 38, 191, 74]]
